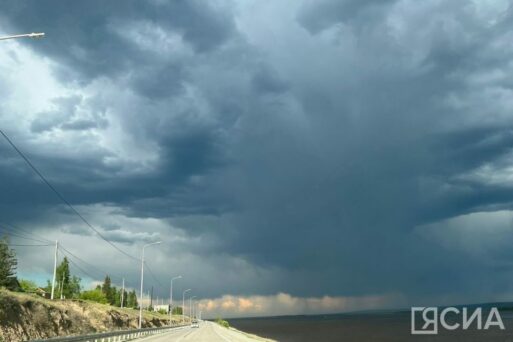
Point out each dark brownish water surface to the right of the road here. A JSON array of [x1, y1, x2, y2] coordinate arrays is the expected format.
[[228, 311, 513, 342]]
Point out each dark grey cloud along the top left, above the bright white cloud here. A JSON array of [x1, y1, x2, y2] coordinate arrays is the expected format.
[[3, 1, 233, 81]]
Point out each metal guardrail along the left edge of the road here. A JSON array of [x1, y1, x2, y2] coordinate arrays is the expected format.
[[30, 324, 190, 342]]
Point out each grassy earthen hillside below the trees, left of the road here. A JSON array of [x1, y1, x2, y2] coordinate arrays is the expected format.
[[0, 289, 181, 341]]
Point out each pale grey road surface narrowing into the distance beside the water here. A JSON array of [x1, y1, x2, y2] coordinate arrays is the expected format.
[[137, 321, 271, 342]]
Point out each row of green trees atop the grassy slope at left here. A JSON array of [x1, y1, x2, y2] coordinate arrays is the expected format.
[[0, 237, 138, 308]]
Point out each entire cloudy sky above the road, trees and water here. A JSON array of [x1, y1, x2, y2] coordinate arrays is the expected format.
[[0, 0, 513, 316]]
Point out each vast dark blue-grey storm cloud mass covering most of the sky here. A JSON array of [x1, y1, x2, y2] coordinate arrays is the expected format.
[[0, 0, 513, 304]]
